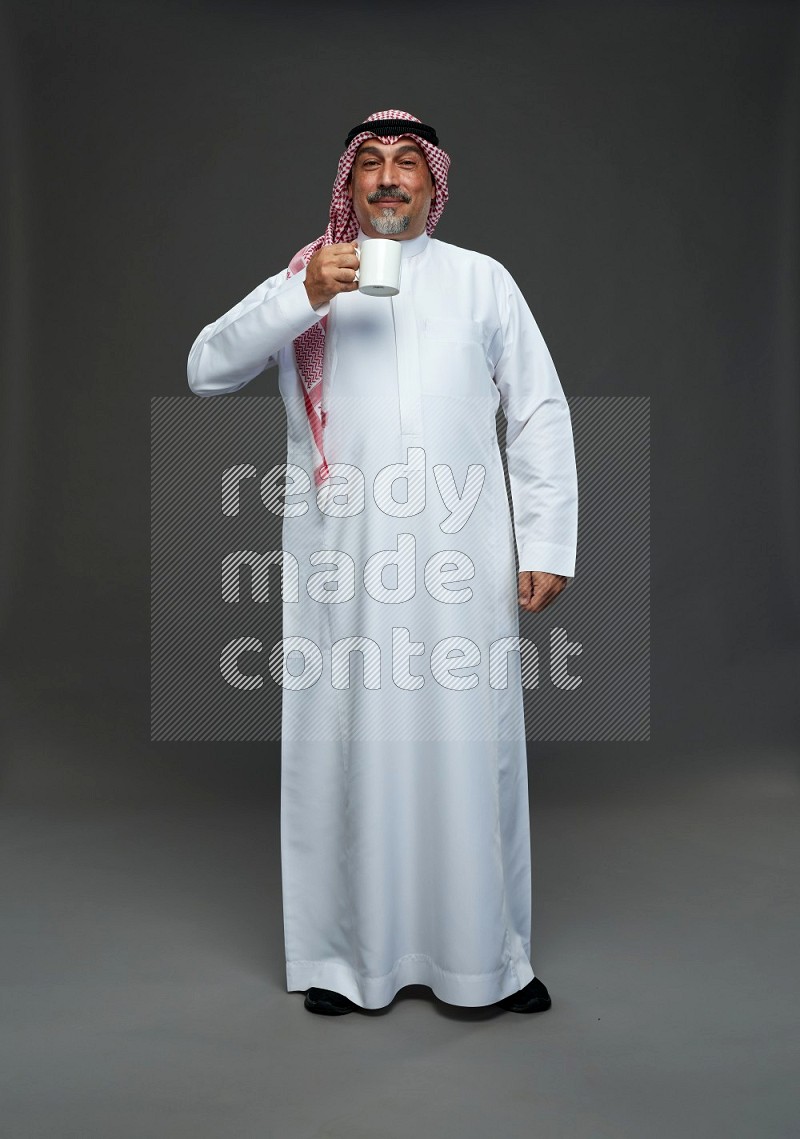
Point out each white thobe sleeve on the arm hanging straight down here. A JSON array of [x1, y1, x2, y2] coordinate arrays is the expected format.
[[493, 270, 578, 581]]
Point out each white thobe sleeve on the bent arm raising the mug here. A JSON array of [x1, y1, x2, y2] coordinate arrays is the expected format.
[[187, 268, 329, 395]]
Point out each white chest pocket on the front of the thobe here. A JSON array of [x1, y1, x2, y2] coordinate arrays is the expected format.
[[419, 317, 492, 400]]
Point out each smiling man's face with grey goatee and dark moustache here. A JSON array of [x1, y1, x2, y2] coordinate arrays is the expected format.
[[348, 137, 435, 240]]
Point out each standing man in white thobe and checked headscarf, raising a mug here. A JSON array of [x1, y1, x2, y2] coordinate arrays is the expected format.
[[188, 110, 578, 1015]]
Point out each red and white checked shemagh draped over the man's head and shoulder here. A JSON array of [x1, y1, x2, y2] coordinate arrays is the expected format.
[[287, 110, 450, 487]]
